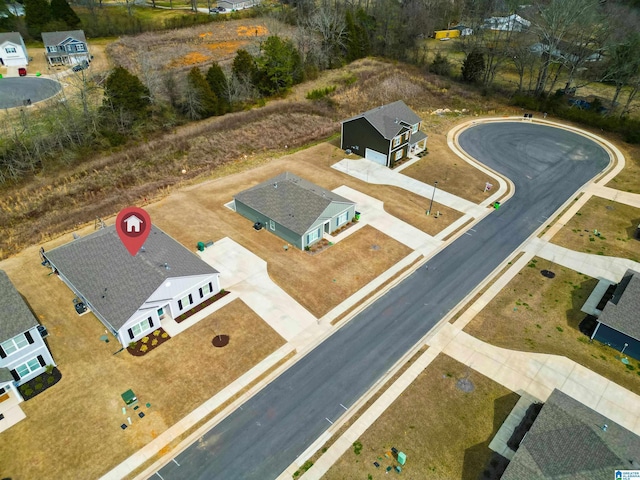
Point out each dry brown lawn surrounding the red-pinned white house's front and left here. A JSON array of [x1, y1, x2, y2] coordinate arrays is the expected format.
[[0, 246, 284, 479]]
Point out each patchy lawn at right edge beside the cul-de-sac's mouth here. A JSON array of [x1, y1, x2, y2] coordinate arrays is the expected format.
[[551, 197, 640, 262]]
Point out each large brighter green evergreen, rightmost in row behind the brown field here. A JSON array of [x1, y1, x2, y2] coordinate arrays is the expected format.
[[254, 36, 303, 95]]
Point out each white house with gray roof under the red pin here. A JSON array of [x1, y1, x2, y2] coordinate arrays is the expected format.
[[43, 226, 220, 347]]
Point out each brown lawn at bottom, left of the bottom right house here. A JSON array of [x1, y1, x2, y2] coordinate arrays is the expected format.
[[323, 355, 519, 480]]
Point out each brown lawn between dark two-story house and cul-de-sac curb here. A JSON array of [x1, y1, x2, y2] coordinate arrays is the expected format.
[[402, 134, 498, 203]]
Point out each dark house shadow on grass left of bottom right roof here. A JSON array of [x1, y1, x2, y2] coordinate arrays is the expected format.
[[462, 392, 520, 480]]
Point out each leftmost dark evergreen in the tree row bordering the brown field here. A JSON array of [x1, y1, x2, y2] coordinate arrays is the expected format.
[[103, 67, 151, 118]]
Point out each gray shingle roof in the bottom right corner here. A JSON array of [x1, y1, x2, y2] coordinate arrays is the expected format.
[[501, 390, 640, 480]]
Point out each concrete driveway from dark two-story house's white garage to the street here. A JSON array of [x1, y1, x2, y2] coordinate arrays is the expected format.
[[331, 158, 485, 217]]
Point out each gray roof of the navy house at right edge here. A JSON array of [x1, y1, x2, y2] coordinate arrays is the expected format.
[[598, 270, 640, 340]]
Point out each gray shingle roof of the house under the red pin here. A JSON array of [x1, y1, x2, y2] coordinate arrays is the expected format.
[[45, 225, 217, 330]]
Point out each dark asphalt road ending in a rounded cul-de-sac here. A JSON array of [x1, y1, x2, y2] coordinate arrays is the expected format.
[[160, 122, 609, 480]]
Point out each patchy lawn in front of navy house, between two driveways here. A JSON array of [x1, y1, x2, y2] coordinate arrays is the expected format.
[[464, 258, 640, 394]]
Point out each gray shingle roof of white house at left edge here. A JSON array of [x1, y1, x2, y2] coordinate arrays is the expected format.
[[0, 270, 38, 342]]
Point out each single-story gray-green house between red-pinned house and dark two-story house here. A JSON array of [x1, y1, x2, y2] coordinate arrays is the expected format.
[[234, 172, 355, 249]]
